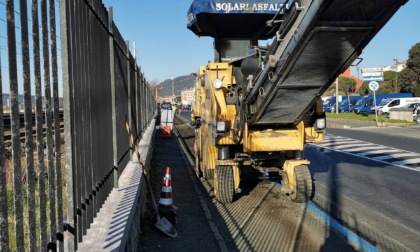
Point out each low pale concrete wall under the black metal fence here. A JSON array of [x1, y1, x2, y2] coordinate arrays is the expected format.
[[77, 119, 155, 251]]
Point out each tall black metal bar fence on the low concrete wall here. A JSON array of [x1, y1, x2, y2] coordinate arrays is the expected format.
[[0, 0, 156, 251]]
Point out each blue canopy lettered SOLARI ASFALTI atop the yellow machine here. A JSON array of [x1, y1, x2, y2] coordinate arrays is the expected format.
[[187, 0, 295, 39]]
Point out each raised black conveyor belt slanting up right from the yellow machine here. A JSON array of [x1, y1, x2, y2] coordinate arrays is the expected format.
[[247, 0, 407, 125]]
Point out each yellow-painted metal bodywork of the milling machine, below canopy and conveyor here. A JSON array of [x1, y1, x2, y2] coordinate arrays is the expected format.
[[191, 63, 324, 203]]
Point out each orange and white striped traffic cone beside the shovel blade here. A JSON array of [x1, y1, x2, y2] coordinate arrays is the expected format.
[[158, 167, 178, 224]]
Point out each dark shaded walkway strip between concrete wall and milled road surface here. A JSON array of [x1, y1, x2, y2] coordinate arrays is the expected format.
[[140, 129, 225, 251]]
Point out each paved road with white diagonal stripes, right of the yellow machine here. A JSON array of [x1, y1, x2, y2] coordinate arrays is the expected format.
[[305, 126, 420, 251]]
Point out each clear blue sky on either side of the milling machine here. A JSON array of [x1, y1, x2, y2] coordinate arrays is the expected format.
[[103, 0, 420, 83]]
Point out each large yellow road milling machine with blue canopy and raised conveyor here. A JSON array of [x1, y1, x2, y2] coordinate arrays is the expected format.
[[188, 0, 407, 203]]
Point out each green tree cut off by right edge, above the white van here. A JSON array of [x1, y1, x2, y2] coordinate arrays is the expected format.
[[398, 43, 420, 96]]
